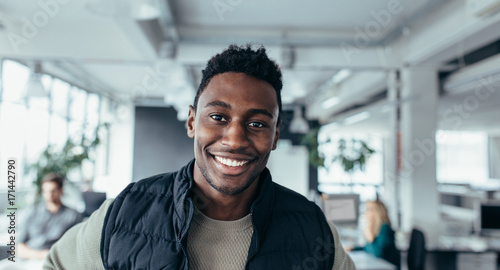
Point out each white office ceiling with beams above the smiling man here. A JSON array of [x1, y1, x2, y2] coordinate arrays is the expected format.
[[0, 0, 500, 133]]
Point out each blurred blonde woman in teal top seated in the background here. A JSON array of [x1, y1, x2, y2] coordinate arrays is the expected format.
[[363, 199, 401, 268]]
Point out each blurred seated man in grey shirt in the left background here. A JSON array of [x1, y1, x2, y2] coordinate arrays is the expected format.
[[19, 173, 82, 260]]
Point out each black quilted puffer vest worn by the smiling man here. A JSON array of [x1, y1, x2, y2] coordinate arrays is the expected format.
[[101, 160, 335, 270]]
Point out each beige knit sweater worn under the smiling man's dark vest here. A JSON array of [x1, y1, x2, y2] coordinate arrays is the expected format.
[[43, 200, 355, 270]]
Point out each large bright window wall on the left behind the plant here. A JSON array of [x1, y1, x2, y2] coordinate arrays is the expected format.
[[0, 60, 101, 189]]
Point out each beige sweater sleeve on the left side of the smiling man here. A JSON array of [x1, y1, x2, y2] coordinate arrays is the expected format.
[[43, 199, 113, 270]]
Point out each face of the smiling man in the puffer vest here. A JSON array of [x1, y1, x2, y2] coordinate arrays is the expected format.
[[188, 72, 279, 195]]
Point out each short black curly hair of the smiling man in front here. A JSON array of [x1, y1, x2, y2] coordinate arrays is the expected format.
[[193, 44, 283, 123]]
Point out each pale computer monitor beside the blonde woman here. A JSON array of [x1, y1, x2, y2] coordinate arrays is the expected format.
[[323, 194, 359, 226]]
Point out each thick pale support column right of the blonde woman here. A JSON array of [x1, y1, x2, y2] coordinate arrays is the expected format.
[[398, 67, 440, 246]]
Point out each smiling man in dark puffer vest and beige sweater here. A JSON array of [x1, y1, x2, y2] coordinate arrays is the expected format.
[[45, 45, 354, 270]]
